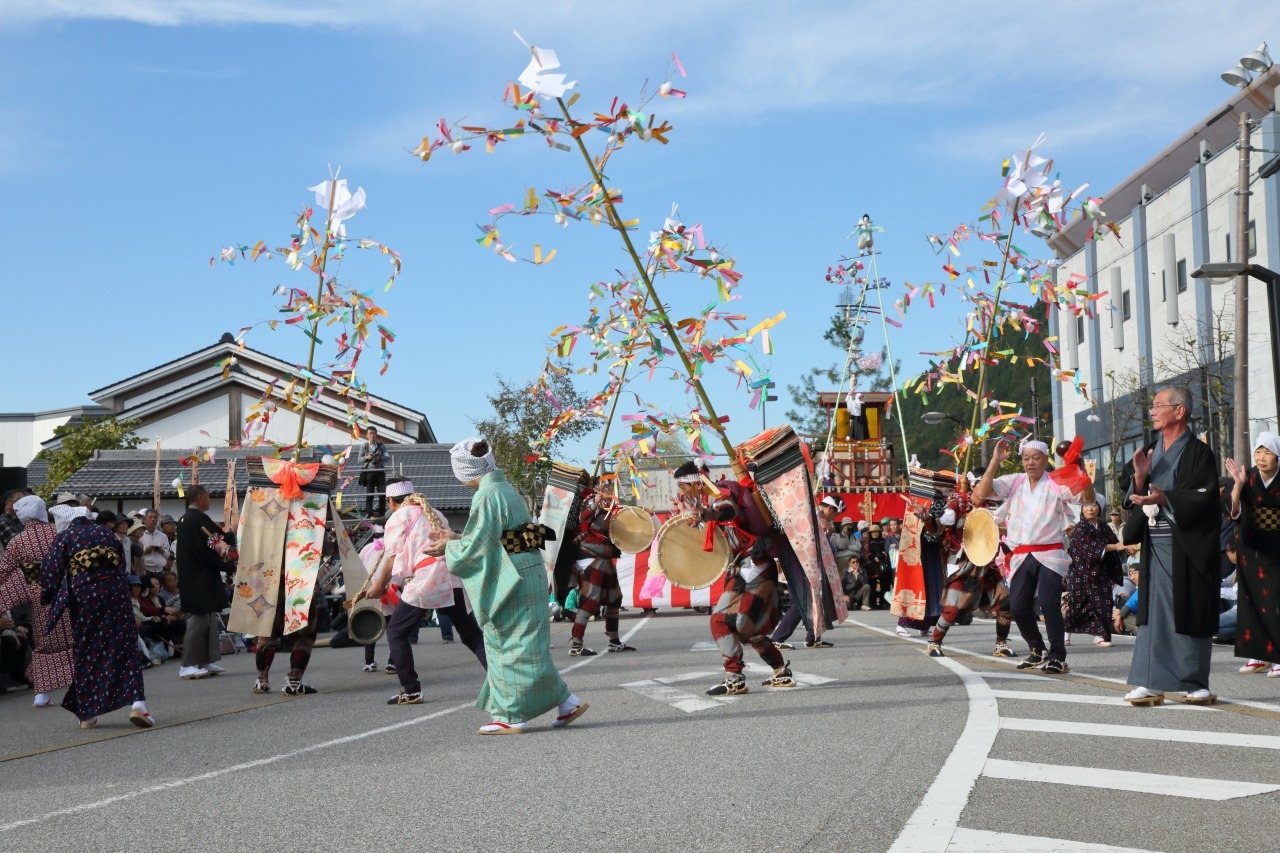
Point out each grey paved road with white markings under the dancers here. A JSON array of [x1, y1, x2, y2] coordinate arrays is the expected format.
[[0, 611, 1280, 852]]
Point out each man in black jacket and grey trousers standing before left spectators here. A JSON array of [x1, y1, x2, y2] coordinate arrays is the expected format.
[[177, 485, 228, 680]]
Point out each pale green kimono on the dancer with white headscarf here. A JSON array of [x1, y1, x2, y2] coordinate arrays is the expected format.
[[444, 471, 570, 724]]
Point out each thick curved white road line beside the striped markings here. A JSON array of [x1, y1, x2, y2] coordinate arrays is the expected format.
[[890, 657, 1000, 853]]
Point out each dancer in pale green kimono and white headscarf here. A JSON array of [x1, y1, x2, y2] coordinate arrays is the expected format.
[[424, 438, 588, 735]]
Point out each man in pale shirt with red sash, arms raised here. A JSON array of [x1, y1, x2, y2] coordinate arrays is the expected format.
[[973, 439, 1096, 674]]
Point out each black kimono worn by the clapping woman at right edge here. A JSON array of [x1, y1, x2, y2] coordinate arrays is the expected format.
[[1228, 467, 1280, 663]]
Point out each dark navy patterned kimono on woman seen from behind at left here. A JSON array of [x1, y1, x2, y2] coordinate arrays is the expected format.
[[40, 517, 145, 721]]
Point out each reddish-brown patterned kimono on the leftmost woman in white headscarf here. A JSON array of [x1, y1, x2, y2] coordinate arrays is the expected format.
[[0, 521, 74, 693]]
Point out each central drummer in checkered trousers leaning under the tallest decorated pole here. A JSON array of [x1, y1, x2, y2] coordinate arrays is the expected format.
[[676, 462, 795, 695]]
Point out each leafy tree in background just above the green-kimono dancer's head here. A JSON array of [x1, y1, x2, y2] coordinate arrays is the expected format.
[[472, 373, 600, 501]]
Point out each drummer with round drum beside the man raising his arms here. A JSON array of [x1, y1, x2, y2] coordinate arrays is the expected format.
[[925, 471, 1016, 657]]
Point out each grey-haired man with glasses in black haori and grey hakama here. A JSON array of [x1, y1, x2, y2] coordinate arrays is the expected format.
[[1124, 386, 1221, 704]]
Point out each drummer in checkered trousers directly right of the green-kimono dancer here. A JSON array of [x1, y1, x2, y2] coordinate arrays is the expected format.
[[568, 478, 635, 657]]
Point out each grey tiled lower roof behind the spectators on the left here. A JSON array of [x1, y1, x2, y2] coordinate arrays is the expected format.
[[53, 444, 471, 512]]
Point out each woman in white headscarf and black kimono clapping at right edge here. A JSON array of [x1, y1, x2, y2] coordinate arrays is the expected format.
[[1226, 433, 1280, 679]]
